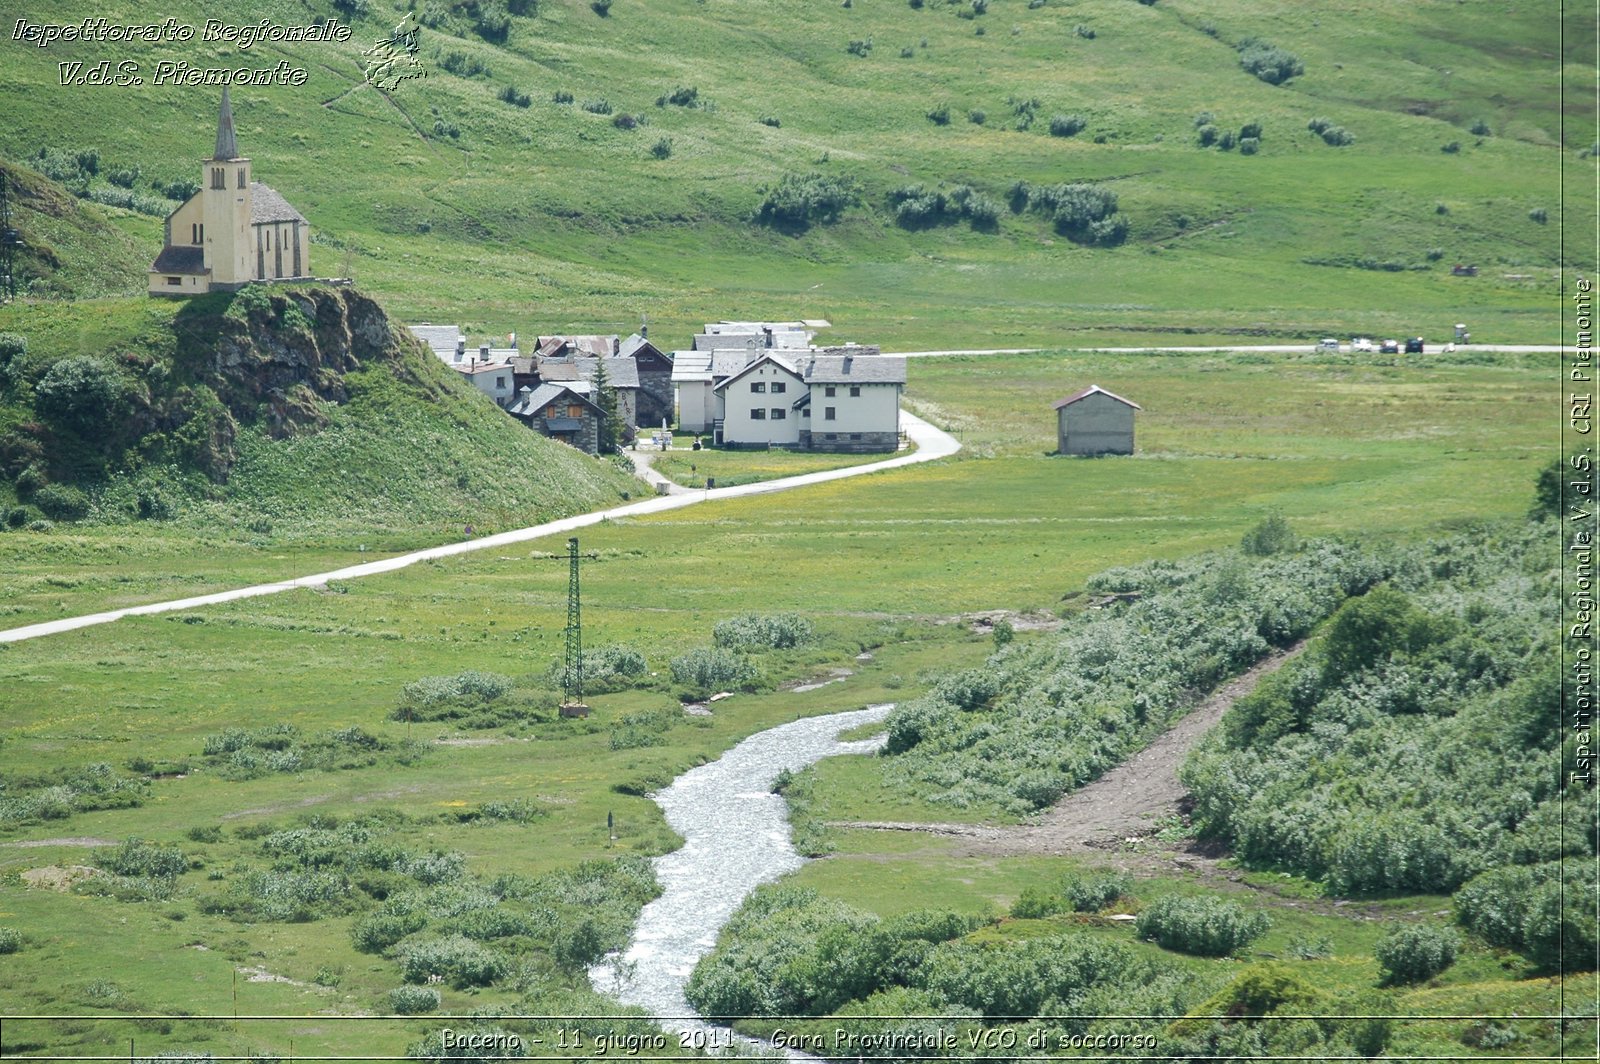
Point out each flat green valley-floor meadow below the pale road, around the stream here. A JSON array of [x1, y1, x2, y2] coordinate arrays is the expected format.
[[0, 342, 1586, 1053]]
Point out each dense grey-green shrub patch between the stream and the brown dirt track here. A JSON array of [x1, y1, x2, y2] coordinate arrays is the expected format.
[[886, 544, 1382, 813]]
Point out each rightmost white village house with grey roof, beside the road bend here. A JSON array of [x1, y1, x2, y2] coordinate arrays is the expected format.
[[797, 347, 906, 453]]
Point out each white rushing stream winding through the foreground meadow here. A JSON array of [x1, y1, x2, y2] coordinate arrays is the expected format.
[[589, 706, 891, 1045]]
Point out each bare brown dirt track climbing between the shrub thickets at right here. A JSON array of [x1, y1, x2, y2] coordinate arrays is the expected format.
[[838, 643, 1304, 864]]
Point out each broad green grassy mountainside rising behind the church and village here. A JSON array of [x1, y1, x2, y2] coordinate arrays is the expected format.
[[0, 0, 1595, 346]]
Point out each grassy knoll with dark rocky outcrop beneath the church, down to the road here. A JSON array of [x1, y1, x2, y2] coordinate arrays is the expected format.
[[0, 286, 642, 619]]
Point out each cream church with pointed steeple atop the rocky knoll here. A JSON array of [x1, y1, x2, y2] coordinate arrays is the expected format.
[[150, 86, 310, 296]]
